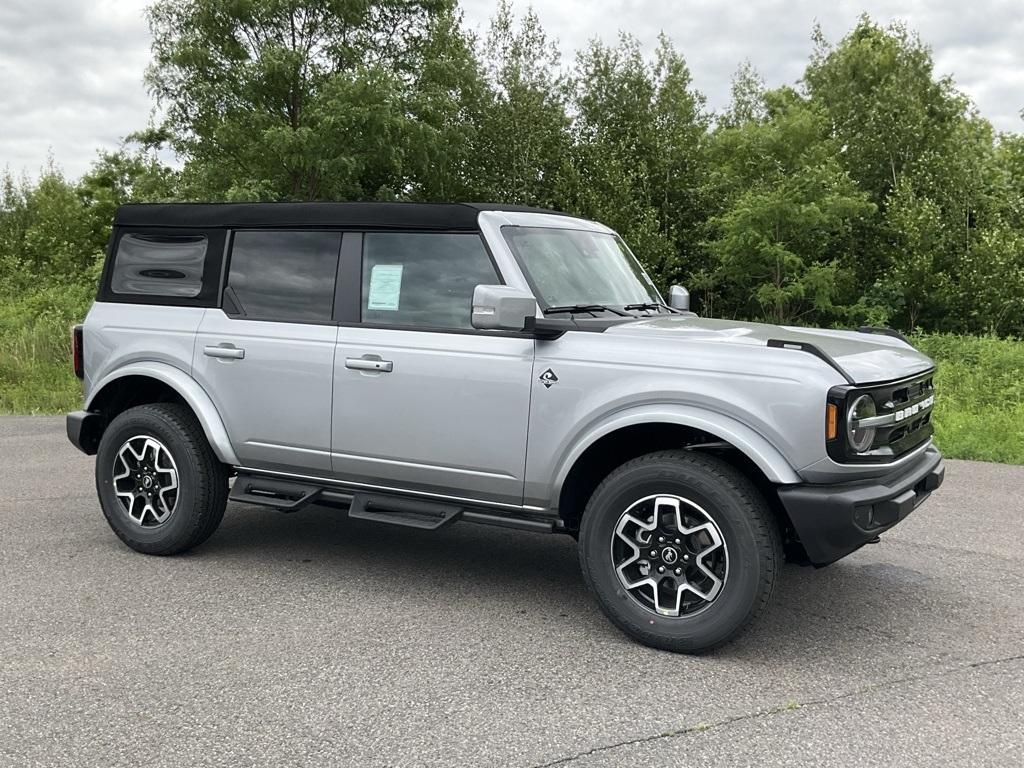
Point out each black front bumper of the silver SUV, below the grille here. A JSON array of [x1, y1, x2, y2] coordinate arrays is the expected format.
[[778, 446, 945, 565]]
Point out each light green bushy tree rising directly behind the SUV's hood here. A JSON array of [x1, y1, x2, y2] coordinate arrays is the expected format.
[[709, 88, 876, 323]]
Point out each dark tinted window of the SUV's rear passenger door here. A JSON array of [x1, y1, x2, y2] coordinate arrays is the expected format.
[[227, 231, 341, 323]]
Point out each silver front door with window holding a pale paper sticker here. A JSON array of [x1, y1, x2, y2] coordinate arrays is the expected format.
[[332, 232, 534, 505]]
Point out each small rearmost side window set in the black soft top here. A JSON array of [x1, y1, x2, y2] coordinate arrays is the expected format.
[[111, 234, 207, 298]]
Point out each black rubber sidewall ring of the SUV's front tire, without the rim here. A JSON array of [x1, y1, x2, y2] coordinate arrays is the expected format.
[[580, 458, 764, 650]]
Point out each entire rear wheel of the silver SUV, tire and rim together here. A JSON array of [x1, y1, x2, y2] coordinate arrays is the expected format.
[[96, 403, 227, 555]]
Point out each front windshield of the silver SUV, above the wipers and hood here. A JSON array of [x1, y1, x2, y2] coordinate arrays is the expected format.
[[502, 226, 662, 308]]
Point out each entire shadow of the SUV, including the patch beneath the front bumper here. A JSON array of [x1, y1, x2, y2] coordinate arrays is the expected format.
[[188, 504, 955, 664]]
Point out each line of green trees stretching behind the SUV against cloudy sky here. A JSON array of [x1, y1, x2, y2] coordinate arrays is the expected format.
[[0, 0, 1024, 336]]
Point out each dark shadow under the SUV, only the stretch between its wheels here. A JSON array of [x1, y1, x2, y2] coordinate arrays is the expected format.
[[199, 504, 589, 612]]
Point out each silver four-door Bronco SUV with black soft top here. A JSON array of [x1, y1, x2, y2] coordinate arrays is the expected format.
[[68, 203, 943, 651]]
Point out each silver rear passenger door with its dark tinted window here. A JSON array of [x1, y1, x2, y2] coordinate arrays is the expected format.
[[193, 230, 341, 475]]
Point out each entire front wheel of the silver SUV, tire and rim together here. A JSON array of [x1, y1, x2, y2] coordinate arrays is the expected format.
[[580, 451, 781, 653]]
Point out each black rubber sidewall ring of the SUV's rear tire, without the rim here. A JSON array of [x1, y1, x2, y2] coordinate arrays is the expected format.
[[96, 408, 201, 553]]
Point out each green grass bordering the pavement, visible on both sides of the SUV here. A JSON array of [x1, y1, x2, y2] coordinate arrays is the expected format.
[[0, 303, 1024, 464]]
